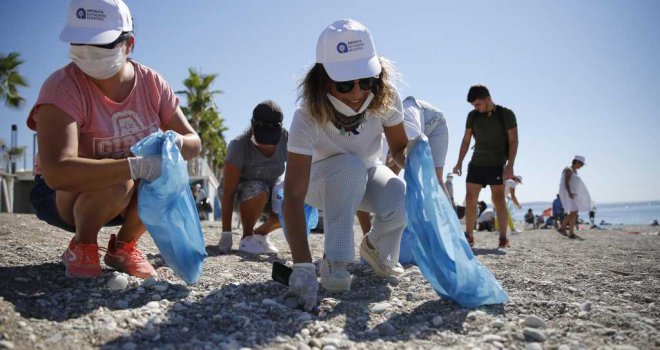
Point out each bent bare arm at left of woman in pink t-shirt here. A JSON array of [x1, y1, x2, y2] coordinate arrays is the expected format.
[[35, 104, 131, 192]]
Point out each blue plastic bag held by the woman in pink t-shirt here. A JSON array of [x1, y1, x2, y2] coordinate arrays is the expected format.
[[131, 131, 207, 284]]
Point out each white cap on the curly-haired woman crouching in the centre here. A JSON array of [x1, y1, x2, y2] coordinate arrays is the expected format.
[[316, 19, 381, 81]]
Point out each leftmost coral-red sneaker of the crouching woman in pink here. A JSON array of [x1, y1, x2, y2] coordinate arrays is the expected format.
[[62, 238, 103, 278]]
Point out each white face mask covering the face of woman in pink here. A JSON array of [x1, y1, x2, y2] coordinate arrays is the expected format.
[[69, 45, 126, 79]]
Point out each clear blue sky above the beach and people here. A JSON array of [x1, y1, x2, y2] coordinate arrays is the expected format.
[[0, 0, 660, 203]]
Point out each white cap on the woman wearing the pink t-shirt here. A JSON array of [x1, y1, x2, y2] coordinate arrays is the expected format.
[[60, 0, 133, 45]]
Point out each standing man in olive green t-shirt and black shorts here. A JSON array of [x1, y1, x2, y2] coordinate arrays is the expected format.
[[454, 85, 518, 248]]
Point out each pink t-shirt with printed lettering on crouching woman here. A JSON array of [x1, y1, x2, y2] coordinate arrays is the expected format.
[[27, 61, 179, 168]]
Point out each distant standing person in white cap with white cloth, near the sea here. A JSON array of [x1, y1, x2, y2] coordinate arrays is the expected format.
[[559, 155, 591, 238]]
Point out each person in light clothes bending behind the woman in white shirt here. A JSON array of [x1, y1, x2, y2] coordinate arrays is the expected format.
[[357, 96, 453, 234]]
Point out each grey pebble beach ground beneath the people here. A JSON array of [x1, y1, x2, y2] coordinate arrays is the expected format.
[[0, 214, 660, 350]]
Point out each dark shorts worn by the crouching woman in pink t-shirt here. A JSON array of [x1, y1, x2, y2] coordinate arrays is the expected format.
[[30, 175, 124, 232]]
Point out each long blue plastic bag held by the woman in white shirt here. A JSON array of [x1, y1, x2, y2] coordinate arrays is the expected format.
[[404, 140, 508, 307]]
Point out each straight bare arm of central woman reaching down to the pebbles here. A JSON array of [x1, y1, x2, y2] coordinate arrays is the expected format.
[[282, 152, 312, 263]]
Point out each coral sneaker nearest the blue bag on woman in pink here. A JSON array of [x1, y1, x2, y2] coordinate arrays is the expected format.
[[103, 234, 158, 278]]
